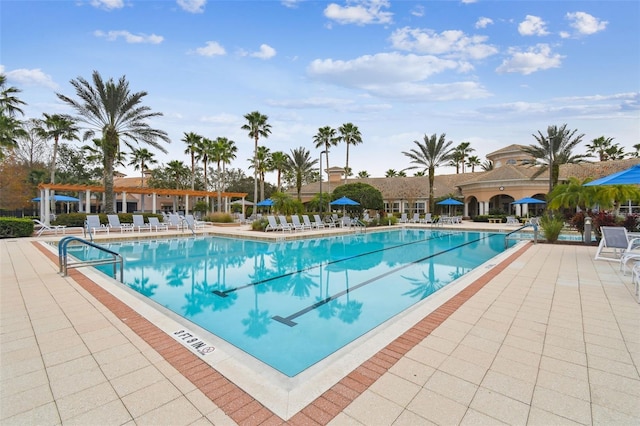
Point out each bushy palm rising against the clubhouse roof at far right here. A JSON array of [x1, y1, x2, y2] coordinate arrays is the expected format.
[[522, 124, 588, 192]]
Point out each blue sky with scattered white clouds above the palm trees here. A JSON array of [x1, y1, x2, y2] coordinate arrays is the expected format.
[[0, 0, 640, 181]]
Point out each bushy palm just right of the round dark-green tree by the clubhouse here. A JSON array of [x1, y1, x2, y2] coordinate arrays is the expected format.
[[402, 133, 454, 212]]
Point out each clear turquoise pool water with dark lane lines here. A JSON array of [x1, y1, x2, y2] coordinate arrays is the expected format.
[[70, 229, 504, 377]]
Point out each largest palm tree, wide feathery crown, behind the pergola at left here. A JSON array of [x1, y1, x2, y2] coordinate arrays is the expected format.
[[56, 71, 170, 213]]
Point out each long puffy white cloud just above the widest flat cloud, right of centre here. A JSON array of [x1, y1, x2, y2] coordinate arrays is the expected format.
[[390, 27, 498, 59]]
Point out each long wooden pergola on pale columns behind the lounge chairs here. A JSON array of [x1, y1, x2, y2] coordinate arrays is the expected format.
[[38, 183, 248, 225]]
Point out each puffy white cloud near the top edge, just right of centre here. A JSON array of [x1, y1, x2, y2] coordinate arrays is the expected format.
[[324, 0, 393, 25]]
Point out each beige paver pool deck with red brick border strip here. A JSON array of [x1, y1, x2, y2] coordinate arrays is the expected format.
[[0, 222, 640, 425]]
